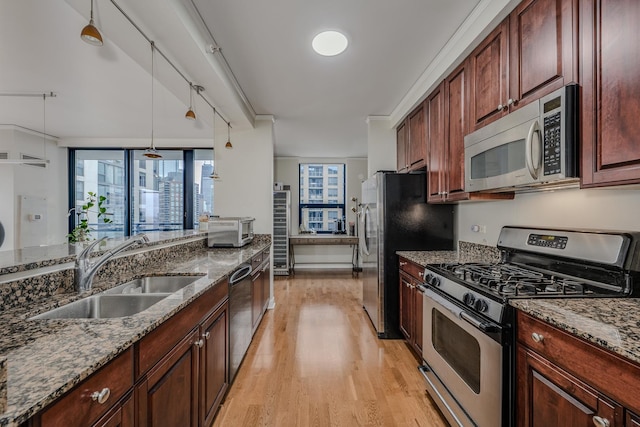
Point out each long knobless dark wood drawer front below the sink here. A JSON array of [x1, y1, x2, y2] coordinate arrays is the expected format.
[[136, 280, 229, 379]]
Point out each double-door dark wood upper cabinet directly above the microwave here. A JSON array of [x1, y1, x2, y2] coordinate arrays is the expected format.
[[469, 0, 577, 131]]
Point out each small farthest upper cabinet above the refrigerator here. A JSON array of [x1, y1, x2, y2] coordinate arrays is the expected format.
[[396, 104, 426, 172]]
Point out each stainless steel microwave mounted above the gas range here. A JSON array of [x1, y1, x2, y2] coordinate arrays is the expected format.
[[464, 84, 580, 192]]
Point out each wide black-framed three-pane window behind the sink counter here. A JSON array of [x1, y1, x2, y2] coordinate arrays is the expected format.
[[69, 149, 213, 238]]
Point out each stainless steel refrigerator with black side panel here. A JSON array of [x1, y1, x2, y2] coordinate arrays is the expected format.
[[360, 171, 453, 338]]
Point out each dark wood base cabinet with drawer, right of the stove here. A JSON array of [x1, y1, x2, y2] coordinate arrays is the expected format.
[[516, 311, 640, 427]]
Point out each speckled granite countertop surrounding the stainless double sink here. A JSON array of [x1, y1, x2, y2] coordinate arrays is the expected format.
[[0, 235, 271, 426]]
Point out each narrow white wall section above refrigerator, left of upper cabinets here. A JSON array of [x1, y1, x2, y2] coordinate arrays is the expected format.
[[366, 116, 397, 178]]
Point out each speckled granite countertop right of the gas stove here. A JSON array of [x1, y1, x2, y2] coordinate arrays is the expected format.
[[509, 298, 640, 363]]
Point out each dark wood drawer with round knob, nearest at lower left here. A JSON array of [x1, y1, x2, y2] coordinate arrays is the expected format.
[[40, 348, 133, 427]]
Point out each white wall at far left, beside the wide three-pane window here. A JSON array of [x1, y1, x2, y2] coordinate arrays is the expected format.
[[0, 128, 68, 251]]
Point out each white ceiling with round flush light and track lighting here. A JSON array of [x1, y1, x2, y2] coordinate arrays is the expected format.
[[0, 0, 506, 157]]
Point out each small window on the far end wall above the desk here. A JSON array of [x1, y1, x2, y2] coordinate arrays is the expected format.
[[299, 164, 345, 233]]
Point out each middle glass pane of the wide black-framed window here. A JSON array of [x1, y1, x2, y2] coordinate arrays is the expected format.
[[131, 150, 184, 234]]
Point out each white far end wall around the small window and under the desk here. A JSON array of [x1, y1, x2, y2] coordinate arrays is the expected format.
[[274, 157, 367, 268]]
